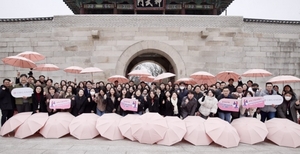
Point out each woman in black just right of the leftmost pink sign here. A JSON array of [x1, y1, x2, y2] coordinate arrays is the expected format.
[[71, 89, 87, 116]]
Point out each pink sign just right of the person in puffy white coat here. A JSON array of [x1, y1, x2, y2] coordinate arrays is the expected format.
[[218, 98, 239, 112]]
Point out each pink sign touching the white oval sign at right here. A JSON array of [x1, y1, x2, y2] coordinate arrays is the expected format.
[[242, 97, 265, 109]]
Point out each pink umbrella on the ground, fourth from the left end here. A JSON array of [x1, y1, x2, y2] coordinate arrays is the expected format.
[[69, 113, 99, 140]]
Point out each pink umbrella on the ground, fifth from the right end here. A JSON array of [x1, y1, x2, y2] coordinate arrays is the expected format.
[[157, 116, 186, 146]]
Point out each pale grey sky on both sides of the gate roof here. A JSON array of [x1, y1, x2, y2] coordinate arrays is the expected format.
[[0, 0, 300, 21]]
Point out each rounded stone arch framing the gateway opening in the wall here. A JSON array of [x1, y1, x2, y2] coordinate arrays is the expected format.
[[115, 41, 186, 78]]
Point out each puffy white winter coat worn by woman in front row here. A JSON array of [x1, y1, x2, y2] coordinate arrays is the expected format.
[[198, 96, 218, 116]]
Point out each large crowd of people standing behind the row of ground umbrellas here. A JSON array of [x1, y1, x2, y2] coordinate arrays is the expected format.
[[0, 74, 300, 125]]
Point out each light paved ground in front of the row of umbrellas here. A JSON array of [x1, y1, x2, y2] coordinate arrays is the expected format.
[[0, 134, 300, 154]]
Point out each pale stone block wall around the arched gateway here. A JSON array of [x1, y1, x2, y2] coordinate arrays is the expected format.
[[0, 15, 300, 93]]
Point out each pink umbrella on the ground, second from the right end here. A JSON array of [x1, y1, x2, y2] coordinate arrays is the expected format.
[[231, 117, 268, 144]]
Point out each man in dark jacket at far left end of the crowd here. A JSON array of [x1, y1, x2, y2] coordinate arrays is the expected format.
[[0, 79, 15, 126]]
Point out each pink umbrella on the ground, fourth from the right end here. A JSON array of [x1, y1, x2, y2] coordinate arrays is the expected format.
[[183, 116, 212, 145]]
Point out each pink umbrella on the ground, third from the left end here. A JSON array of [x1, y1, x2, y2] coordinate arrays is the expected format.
[[40, 112, 74, 138]]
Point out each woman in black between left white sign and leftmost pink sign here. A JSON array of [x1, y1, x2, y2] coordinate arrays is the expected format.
[[32, 86, 48, 113]]
